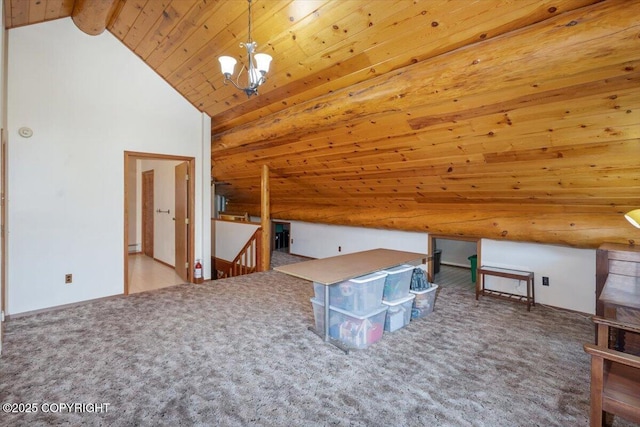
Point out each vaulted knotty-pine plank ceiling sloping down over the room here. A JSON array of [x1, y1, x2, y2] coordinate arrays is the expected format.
[[5, 0, 640, 247]]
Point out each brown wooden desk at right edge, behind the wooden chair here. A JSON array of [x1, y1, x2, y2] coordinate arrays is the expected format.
[[596, 243, 640, 355]]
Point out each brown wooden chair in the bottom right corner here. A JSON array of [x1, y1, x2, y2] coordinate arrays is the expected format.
[[584, 316, 640, 427]]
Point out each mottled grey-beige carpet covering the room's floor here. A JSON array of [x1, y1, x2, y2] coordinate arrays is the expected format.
[[0, 255, 632, 427]]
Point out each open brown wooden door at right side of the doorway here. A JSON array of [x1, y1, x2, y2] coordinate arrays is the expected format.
[[175, 162, 190, 282]]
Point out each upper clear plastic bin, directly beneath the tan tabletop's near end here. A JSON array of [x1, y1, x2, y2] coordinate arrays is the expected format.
[[313, 272, 387, 314]]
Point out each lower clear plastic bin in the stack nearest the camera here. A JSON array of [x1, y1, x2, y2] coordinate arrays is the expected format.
[[311, 298, 387, 349]]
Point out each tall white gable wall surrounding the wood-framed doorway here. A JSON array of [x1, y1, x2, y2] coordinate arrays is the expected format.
[[7, 19, 210, 314]]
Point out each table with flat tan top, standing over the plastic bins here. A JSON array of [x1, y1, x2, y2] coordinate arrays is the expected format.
[[274, 249, 428, 353]]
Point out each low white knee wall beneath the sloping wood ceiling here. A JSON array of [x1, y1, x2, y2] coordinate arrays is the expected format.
[[283, 220, 596, 314]]
